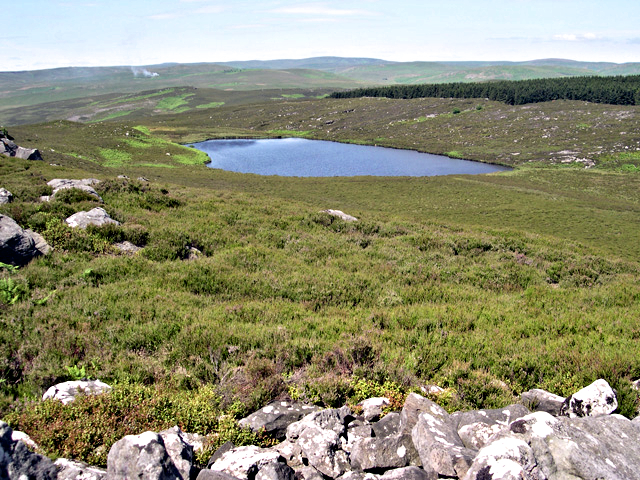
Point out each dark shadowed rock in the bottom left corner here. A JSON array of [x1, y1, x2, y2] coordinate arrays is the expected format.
[[0, 420, 58, 480]]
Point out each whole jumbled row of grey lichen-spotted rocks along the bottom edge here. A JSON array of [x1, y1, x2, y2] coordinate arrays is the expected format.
[[0, 380, 640, 480]]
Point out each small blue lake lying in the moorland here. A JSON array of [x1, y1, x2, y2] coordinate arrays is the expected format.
[[193, 138, 510, 177]]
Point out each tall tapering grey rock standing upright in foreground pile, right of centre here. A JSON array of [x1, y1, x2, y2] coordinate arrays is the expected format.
[[411, 399, 476, 477]]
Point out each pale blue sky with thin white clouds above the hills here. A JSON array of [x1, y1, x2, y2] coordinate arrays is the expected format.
[[5, 0, 640, 71]]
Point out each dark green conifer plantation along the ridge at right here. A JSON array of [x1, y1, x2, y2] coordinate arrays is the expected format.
[[330, 75, 640, 105]]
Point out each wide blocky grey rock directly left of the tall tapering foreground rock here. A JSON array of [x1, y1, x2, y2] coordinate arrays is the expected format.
[[350, 433, 421, 470]]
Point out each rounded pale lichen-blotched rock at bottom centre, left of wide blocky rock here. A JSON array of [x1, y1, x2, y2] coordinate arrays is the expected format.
[[297, 426, 351, 478]]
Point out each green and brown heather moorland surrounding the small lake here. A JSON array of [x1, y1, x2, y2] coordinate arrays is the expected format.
[[0, 60, 640, 465]]
